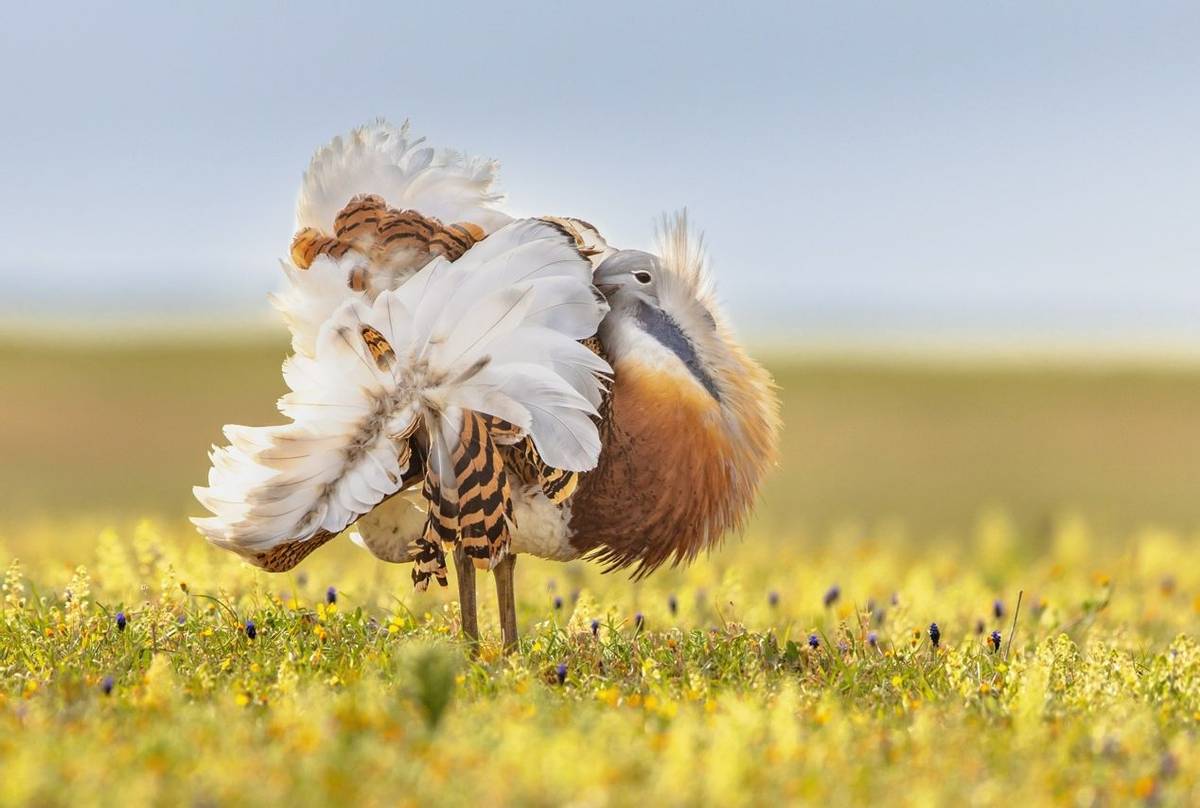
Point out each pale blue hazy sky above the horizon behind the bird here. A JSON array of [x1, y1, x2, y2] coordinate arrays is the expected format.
[[0, 2, 1200, 342]]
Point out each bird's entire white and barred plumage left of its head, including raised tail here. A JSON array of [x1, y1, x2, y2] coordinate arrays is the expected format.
[[193, 122, 611, 587]]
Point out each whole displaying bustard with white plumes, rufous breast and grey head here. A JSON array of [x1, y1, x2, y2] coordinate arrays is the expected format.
[[193, 121, 780, 648]]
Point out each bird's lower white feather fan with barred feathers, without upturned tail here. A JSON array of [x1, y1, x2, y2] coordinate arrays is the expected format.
[[193, 220, 611, 586]]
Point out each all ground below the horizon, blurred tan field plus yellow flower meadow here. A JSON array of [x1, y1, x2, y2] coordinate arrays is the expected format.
[[0, 334, 1200, 806]]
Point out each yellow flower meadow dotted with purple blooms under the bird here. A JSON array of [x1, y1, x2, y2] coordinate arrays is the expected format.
[[0, 513, 1200, 806]]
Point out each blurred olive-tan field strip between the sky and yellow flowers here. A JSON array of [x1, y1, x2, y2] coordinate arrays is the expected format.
[[7, 334, 1200, 538]]
